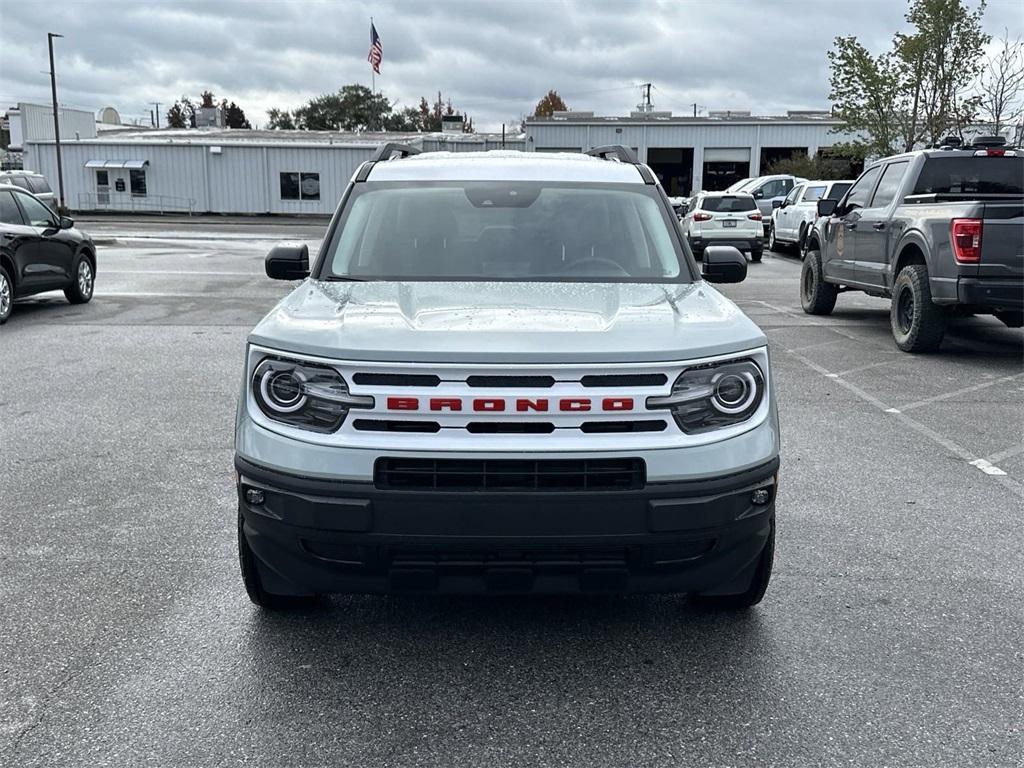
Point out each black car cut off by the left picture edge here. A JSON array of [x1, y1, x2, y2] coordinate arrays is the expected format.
[[0, 184, 96, 325]]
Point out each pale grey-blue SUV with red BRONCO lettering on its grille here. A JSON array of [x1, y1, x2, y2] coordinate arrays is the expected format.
[[234, 144, 779, 607]]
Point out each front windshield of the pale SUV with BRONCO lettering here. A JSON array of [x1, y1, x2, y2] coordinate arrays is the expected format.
[[321, 181, 692, 283]]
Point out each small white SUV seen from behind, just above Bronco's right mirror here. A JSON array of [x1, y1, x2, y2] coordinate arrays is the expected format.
[[682, 193, 764, 261]]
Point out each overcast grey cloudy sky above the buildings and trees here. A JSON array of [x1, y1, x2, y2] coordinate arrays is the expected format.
[[0, 0, 1024, 130]]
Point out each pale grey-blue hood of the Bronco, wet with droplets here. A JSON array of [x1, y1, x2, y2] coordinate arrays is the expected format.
[[249, 280, 766, 362]]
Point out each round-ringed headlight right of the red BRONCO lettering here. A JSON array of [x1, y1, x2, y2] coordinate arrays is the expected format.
[[647, 359, 765, 434]]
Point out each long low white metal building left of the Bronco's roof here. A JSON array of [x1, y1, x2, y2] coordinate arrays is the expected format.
[[25, 129, 525, 215]]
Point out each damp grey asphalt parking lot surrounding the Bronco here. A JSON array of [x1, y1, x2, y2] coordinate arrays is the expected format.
[[0, 221, 1024, 767]]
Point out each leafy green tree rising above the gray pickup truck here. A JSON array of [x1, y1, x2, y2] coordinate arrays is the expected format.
[[827, 0, 989, 155]]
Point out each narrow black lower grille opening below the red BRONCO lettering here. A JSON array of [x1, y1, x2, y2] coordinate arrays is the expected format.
[[374, 458, 646, 490]]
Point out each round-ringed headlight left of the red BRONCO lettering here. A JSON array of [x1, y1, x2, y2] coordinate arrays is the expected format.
[[252, 357, 374, 432]]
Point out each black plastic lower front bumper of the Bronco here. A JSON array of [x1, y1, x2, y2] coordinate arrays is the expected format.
[[236, 457, 778, 594]]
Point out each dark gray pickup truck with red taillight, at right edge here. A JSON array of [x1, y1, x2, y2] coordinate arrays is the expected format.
[[801, 142, 1024, 352]]
